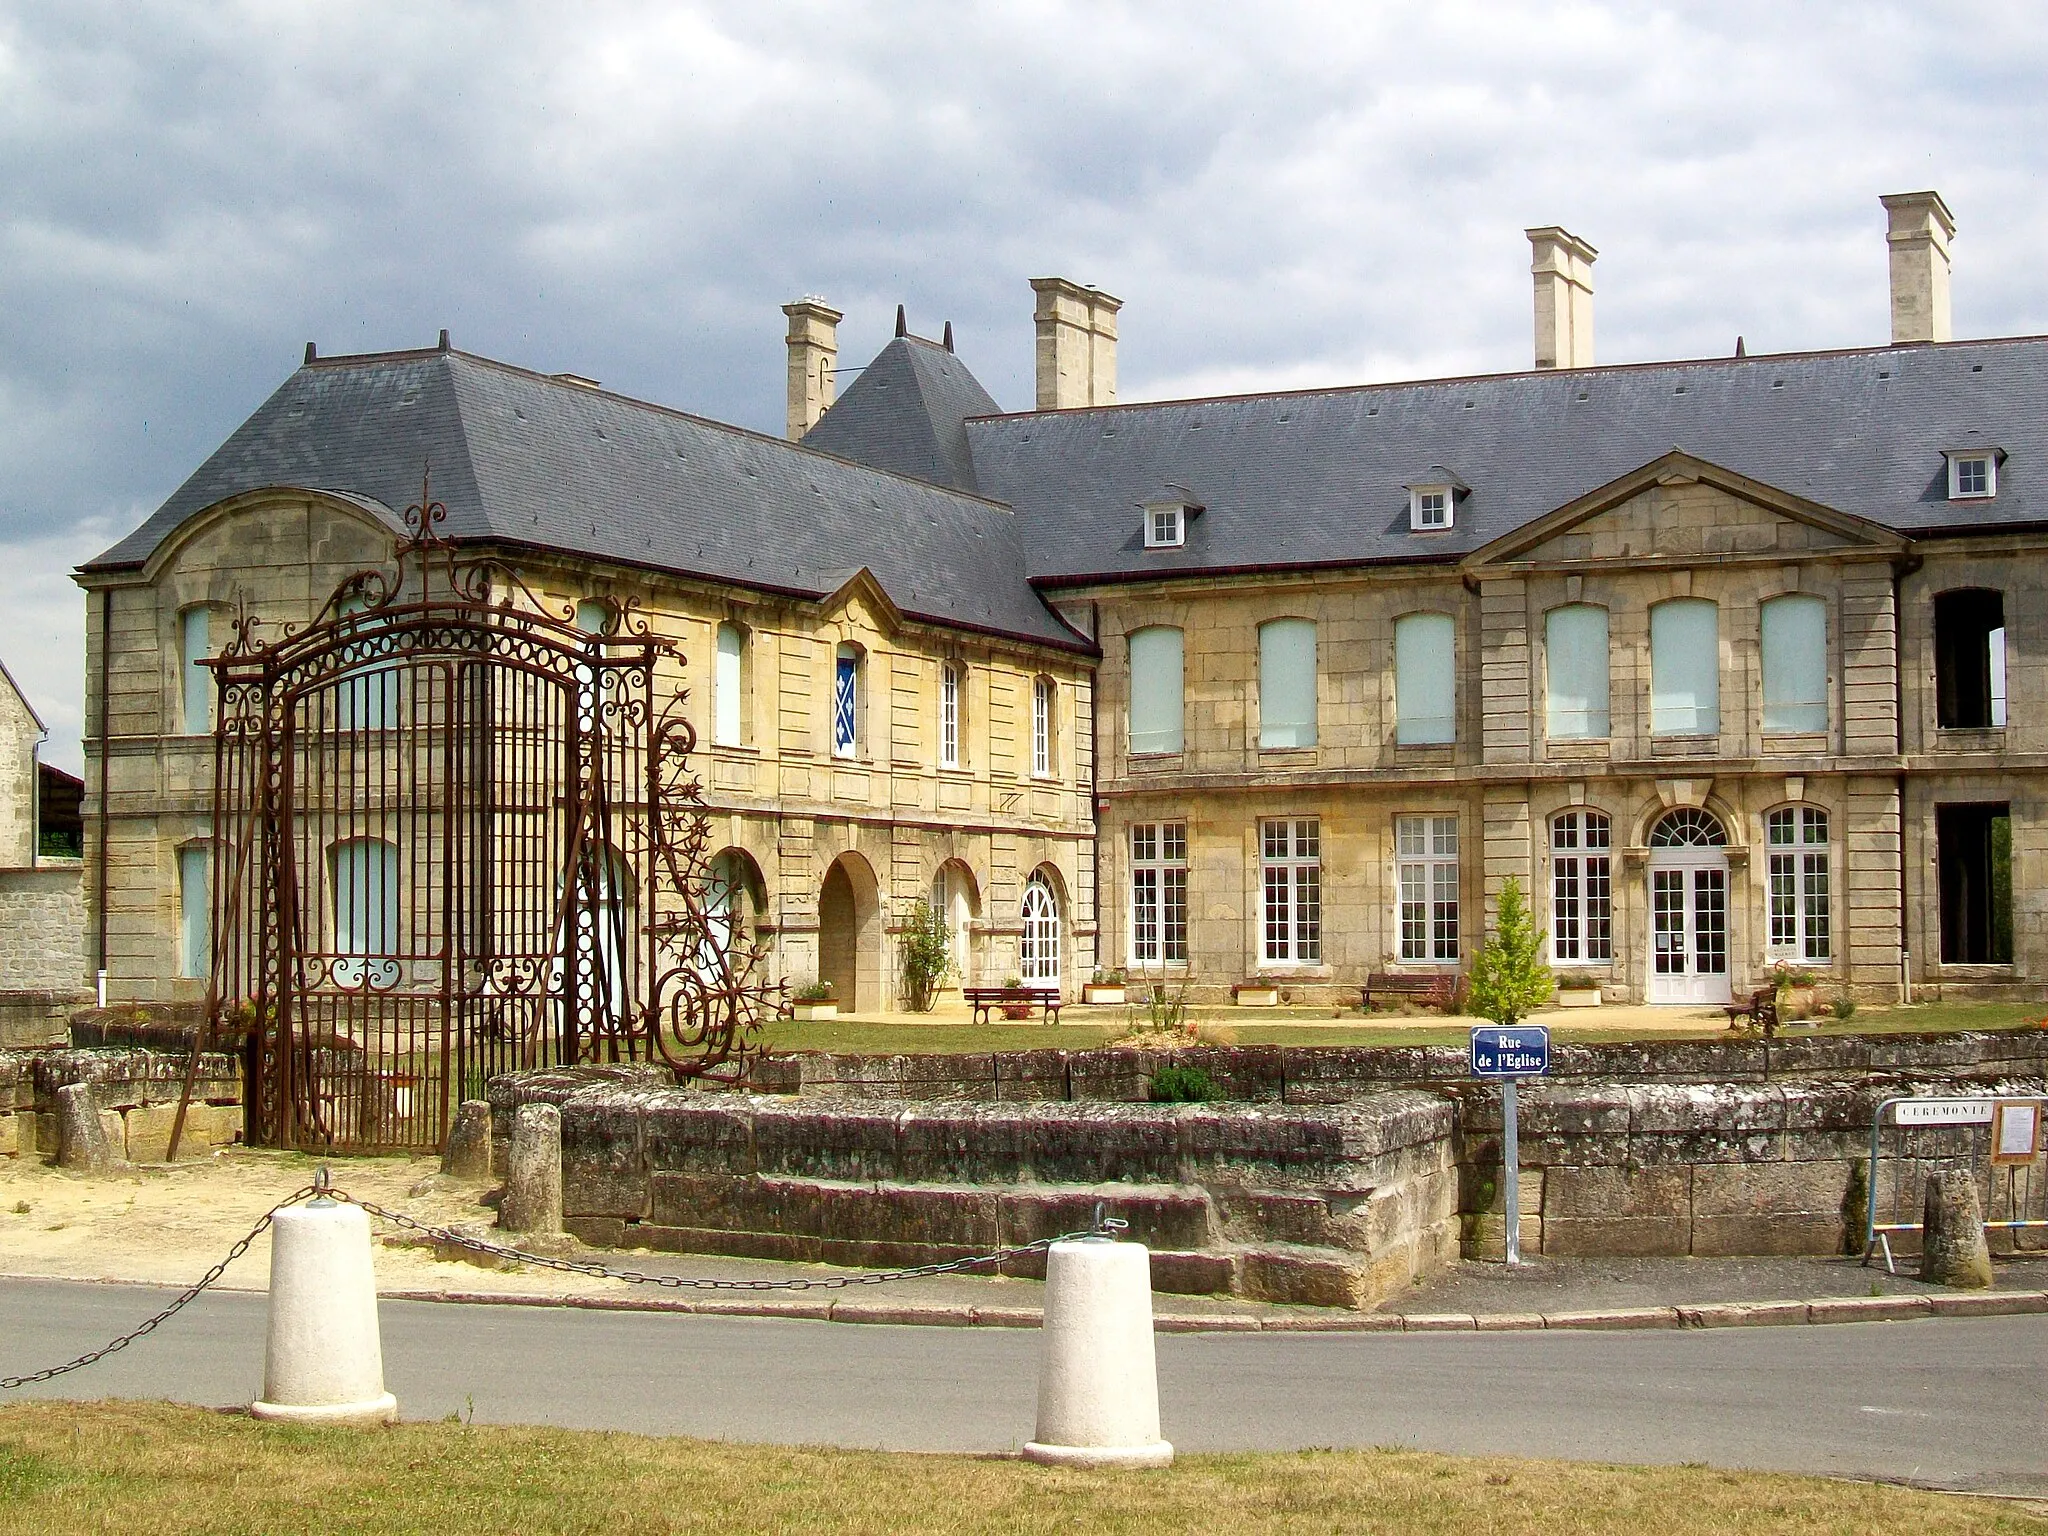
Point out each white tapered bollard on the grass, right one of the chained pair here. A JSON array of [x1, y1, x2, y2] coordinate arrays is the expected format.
[[1024, 1237, 1174, 1466]]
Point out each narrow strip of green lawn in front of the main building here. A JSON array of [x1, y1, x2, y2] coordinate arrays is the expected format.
[[766, 1004, 2044, 1055]]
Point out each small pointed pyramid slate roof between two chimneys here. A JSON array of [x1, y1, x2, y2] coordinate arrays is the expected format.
[[803, 336, 1001, 492]]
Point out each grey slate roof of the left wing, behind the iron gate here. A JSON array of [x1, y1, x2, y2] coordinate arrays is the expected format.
[[84, 350, 1090, 649]]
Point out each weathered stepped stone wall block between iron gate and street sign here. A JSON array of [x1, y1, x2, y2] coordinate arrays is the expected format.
[[492, 1069, 1458, 1307]]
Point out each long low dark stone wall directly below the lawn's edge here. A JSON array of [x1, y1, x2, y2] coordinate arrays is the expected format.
[[748, 1030, 2048, 1104]]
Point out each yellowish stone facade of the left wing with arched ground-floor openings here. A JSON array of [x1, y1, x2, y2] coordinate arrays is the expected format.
[[86, 492, 1094, 1008]]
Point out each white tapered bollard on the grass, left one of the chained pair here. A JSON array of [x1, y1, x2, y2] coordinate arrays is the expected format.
[[250, 1200, 397, 1425]]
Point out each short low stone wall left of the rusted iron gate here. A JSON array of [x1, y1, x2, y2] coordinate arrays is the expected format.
[[0, 1051, 242, 1163]]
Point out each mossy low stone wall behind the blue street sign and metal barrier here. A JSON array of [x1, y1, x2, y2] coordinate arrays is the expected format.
[[1456, 1075, 2048, 1257]]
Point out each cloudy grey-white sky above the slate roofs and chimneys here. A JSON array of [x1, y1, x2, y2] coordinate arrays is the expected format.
[[0, 0, 2048, 768]]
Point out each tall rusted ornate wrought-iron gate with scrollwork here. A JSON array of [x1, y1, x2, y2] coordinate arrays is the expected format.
[[174, 492, 774, 1151]]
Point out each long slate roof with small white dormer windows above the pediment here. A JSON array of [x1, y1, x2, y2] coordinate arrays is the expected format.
[[954, 338, 2048, 586]]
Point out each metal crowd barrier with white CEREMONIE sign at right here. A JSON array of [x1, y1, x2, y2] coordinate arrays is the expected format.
[[1864, 1094, 2048, 1274]]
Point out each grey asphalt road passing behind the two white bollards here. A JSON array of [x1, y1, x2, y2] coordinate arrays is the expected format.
[[0, 1280, 2048, 1493]]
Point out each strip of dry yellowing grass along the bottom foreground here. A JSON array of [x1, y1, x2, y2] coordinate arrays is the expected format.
[[0, 1403, 2048, 1536]]
